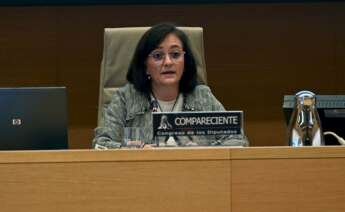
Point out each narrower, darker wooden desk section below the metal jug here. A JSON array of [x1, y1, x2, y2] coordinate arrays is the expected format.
[[231, 147, 345, 212]]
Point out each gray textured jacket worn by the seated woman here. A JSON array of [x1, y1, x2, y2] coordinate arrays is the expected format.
[[93, 83, 247, 148]]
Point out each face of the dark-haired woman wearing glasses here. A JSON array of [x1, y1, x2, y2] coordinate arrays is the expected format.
[[146, 33, 185, 88]]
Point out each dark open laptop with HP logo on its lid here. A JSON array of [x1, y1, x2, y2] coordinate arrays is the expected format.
[[0, 87, 68, 150]]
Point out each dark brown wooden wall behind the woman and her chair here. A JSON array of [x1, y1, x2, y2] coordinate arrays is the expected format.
[[0, 3, 345, 148]]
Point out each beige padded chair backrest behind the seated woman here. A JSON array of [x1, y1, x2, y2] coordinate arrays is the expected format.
[[98, 27, 207, 126]]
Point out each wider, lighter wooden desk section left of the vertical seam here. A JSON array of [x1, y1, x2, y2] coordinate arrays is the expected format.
[[0, 150, 230, 212]]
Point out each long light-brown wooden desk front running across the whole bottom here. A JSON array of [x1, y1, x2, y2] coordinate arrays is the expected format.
[[0, 147, 345, 212]]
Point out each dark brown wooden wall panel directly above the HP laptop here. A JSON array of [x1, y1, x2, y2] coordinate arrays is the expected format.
[[0, 7, 57, 86]]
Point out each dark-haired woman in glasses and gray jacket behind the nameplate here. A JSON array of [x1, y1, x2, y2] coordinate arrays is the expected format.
[[93, 24, 246, 148]]
